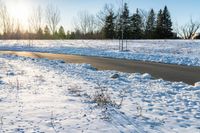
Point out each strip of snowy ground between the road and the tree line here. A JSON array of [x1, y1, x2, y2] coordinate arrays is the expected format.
[[0, 40, 200, 66]]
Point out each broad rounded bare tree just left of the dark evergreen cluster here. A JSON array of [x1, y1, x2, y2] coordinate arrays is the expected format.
[[74, 11, 96, 34]]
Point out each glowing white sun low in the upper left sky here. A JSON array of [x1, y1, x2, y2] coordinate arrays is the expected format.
[[8, 0, 31, 25]]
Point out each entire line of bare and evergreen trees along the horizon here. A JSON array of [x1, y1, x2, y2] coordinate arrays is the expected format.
[[0, 1, 200, 39]]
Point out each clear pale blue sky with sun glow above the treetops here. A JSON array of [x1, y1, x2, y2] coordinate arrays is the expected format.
[[2, 0, 200, 30]]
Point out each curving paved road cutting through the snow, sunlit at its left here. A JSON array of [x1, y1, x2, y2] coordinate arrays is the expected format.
[[0, 51, 200, 85]]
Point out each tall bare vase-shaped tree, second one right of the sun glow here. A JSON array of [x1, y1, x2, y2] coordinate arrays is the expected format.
[[46, 5, 60, 34]]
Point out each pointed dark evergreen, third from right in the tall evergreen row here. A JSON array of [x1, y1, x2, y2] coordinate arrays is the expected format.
[[145, 9, 156, 39]]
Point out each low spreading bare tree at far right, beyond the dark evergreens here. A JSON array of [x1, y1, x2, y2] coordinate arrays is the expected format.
[[176, 19, 200, 39]]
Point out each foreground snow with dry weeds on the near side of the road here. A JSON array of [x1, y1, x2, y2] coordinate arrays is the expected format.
[[0, 55, 200, 133]]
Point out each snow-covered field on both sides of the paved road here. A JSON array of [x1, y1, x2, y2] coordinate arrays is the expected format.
[[0, 40, 200, 133]]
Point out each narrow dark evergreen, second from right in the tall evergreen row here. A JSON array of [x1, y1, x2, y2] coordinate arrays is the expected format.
[[156, 9, 163, 39]]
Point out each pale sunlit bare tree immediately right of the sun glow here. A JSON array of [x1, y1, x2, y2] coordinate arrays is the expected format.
[[29, 6, 42, 33]]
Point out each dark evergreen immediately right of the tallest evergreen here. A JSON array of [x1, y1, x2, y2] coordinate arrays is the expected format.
[[130, 9, 143, 39]]
